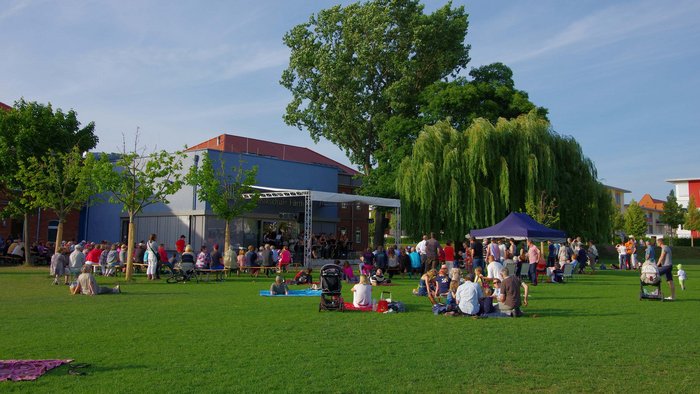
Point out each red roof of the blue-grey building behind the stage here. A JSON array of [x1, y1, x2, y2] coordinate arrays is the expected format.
[[187, 134, 359, 175]]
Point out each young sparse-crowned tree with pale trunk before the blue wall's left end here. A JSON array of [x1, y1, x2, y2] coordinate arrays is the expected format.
[[96, 137, 185, 280]]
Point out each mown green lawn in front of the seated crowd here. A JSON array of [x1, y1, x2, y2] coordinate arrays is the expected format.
[[0, 261, 700, 393]]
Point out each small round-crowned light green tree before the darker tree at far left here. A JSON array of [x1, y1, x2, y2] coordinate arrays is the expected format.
[[17, 147, 104, 253]]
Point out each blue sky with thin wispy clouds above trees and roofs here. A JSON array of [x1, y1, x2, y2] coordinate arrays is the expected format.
[[0, 0, 700, 199]]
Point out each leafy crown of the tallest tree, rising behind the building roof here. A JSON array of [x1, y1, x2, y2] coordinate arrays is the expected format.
[[281, 0, 469, 175]]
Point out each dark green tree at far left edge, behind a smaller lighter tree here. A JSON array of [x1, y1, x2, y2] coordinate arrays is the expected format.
[[0, 99, 98, 264]]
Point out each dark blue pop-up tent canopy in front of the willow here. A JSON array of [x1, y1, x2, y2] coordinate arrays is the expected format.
[[469, 212, 566, 242]]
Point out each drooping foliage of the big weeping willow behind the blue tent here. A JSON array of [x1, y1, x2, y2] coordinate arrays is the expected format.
[[396, 111, 611, 238]]
